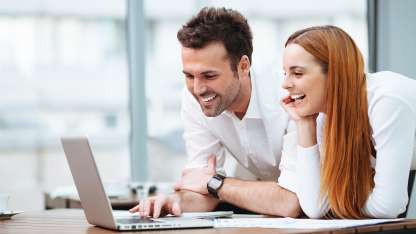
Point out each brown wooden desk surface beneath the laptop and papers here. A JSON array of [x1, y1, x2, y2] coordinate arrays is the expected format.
[[0, 209, 416, 234]]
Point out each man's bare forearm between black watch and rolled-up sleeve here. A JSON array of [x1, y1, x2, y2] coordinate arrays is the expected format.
[[218, 178, 300, 217]]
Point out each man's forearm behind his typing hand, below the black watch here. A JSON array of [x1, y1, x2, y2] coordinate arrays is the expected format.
[[172, 190, 219, 212]]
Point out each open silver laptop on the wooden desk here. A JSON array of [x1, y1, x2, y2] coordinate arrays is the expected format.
[[62, 137, 213, 231]]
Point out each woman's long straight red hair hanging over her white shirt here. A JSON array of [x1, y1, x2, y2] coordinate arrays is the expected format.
[[286, 26, 374, 219]]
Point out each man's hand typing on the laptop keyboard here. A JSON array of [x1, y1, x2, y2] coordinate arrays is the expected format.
[[129, 194, 182, 218]]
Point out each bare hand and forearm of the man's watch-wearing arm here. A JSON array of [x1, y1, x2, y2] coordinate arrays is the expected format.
[[176, 156, 300, 217]]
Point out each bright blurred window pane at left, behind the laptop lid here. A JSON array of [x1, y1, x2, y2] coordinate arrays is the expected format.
[[0, 0, 130, 211]]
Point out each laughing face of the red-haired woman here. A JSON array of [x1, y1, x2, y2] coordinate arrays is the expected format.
[[282, 43, 326, 117]]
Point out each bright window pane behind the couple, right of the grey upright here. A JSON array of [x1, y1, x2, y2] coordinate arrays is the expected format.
[[144, 0, 368, 181]]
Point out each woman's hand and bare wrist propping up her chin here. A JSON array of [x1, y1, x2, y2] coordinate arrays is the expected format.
[[280, 96, 319, 148]]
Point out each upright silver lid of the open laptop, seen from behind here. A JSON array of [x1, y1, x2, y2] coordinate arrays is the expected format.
[[61, 137, 117, 229]]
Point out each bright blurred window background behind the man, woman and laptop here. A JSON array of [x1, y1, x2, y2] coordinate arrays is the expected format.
[[0, 0, 416, 211]]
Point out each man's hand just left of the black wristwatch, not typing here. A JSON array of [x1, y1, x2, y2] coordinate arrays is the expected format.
[[175, 155, 216, 195]]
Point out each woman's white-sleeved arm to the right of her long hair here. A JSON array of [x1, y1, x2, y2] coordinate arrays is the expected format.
[[363, 97, 416, 218]]
